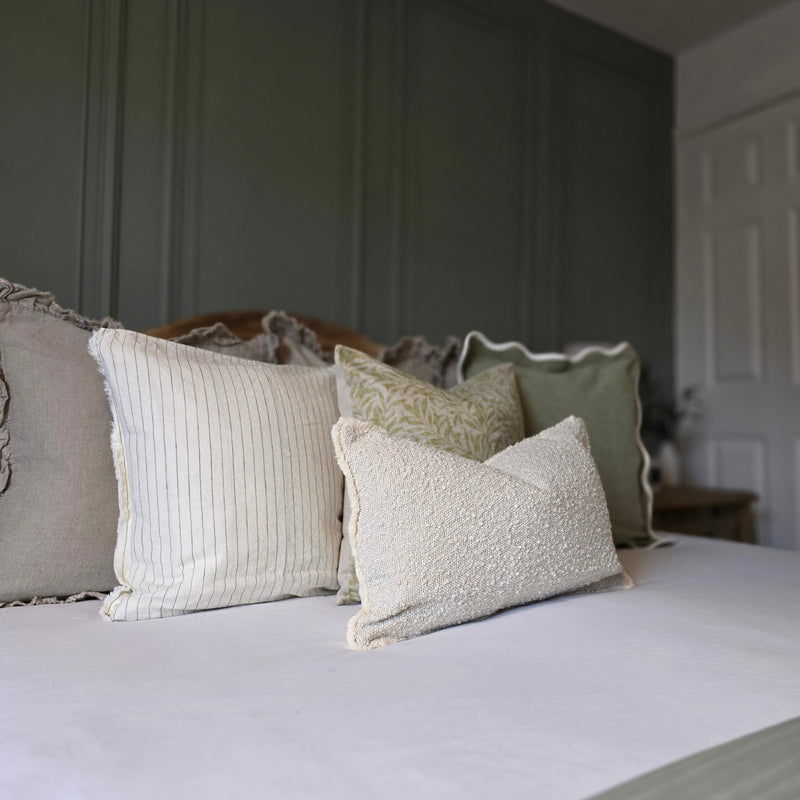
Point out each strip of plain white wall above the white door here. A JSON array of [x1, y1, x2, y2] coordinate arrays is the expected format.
[[675, 0, 800, 133]]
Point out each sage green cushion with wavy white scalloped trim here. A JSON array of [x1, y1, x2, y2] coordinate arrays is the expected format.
[[459, 331, 654, 544]]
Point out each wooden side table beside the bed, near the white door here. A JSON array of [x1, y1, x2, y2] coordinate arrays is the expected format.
[[653, 486, 758, 544]]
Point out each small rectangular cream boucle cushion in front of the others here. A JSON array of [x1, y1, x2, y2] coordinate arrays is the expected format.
[[333, 417, 627, 650]]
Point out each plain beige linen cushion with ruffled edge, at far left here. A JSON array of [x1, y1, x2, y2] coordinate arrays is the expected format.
[[0, 278, 118, 605]]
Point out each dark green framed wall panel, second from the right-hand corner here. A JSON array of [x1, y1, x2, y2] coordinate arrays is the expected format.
[[392, 0, 533, 338]]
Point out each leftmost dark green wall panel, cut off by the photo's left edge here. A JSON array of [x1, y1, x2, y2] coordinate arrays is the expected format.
[[0, 0, 91, 306]]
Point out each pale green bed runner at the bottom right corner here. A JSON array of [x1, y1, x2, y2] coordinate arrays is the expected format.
[[591, 717, 800, 800]]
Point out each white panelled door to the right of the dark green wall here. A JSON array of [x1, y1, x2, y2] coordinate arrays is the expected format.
[[676, 94, 800, 550]]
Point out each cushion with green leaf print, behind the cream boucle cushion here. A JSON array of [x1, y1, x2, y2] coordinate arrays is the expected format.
[[335, 345, 524, 605]]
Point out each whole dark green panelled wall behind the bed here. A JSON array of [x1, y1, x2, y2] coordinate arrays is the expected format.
[[0, 0, 672, 381]]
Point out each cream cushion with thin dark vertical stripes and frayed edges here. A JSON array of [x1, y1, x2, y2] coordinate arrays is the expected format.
[[89, 330, 343, 620]]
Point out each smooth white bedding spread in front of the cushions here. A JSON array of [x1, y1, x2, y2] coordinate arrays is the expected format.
[[0, 537, 800, 800]]
